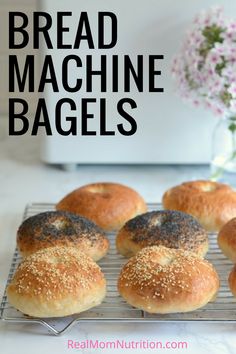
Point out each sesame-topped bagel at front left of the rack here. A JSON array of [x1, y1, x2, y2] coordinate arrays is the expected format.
[[7, 247, 106, 317]]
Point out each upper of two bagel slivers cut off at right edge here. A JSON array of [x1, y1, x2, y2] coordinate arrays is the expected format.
[[217, 218, 236, 263]]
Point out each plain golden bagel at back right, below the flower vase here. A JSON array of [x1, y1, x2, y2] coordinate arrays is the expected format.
[[162, 181, 236, 231]]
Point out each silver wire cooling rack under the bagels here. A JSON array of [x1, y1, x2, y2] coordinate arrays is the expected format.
[[0, 203, 236, 335]]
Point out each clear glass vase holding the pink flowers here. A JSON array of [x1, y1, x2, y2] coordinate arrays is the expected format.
[[211, 115, 236, 186]]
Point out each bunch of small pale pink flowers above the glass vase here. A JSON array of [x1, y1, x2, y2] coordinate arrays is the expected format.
[[172, 7, 236, 115]]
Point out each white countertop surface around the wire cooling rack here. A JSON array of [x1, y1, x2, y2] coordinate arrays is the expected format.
[[0, 134, 236, 354]]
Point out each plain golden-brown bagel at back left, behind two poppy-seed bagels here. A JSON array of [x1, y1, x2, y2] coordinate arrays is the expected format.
[[56, 183, 147, 231]]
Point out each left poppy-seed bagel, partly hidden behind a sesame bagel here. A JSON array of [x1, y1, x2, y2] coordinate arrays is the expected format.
[[17, 211, 109, 261]]
